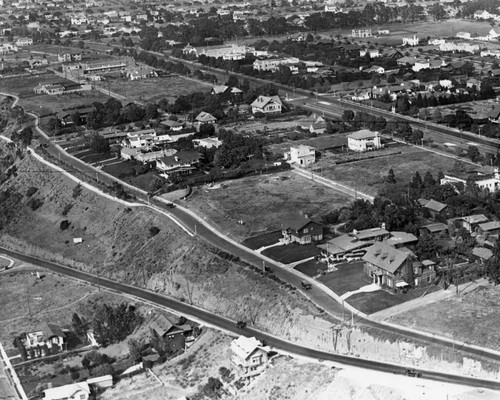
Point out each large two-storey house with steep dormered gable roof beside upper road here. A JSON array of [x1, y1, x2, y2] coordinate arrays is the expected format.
[[363, 242, 414, 290]]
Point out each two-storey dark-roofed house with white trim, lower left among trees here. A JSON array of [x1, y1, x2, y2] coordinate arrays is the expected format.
[[24, 323, 66, 358]]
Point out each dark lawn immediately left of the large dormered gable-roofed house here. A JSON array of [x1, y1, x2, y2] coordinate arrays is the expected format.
[[318, 261, 370, 299]]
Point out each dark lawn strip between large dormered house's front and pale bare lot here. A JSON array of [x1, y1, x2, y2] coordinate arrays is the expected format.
[[346, 286, 440, 316]]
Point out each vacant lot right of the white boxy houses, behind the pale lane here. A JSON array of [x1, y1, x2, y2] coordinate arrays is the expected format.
[[322, 147, 470, 195]]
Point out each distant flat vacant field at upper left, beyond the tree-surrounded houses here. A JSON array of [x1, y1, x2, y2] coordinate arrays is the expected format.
[[100, 76, 212, 102]]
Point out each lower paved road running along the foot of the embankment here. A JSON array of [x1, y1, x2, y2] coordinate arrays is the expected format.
[[0, 248, 500, 390]]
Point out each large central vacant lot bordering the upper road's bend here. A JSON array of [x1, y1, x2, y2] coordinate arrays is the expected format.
[[188, 172, 351, 240]]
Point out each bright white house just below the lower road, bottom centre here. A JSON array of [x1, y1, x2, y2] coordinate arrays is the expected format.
[[230, 336, 269, 377]]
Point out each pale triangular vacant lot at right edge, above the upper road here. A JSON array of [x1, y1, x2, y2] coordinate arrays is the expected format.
[[390, 286, 500, 350]]
